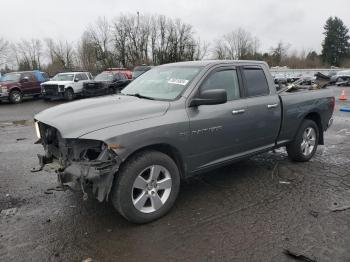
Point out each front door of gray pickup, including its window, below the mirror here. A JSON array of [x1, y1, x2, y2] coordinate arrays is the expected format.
[[187, 66, 248, 170]]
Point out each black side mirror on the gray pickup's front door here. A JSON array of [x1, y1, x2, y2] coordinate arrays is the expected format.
[[190, 89, 227, 107]]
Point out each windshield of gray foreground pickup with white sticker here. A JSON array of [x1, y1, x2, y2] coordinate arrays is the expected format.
[[122, 66, 203, 100]]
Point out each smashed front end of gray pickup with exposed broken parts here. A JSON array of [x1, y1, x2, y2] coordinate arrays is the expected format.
[[34, 123, 121, 202]]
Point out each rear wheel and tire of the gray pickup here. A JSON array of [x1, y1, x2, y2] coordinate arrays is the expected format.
[[287, 119, 320, 162]]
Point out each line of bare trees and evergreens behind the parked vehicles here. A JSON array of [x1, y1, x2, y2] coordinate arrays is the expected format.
[[0, 14, 350, 75]]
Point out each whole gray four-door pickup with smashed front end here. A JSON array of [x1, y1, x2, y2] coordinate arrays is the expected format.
[[35, 61, 335, 223]]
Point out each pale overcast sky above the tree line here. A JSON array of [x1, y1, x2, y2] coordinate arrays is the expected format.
[[0, 0, 350, 52]]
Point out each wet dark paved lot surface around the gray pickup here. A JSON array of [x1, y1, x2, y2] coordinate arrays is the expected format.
[[0, 88, 350, 261]]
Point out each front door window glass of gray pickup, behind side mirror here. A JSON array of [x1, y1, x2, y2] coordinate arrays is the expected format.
[[200, 69, 240, 101]]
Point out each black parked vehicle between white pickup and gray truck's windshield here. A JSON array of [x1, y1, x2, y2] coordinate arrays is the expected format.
[[82, 71, 131, 97]]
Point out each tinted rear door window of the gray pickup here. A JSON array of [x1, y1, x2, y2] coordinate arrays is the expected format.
[[243, 68, 269, 97]]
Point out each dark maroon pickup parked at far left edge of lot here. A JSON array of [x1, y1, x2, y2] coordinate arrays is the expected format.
[[0, 70, 49, 104]]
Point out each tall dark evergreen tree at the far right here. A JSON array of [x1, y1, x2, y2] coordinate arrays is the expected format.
[[322, 17, 350, 66]]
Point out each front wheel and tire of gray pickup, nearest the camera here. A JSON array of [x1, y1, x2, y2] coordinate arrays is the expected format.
[[112, 151, 180, 224]]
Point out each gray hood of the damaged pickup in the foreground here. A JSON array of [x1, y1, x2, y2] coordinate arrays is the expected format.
[[34, 95, 169, 138]]
